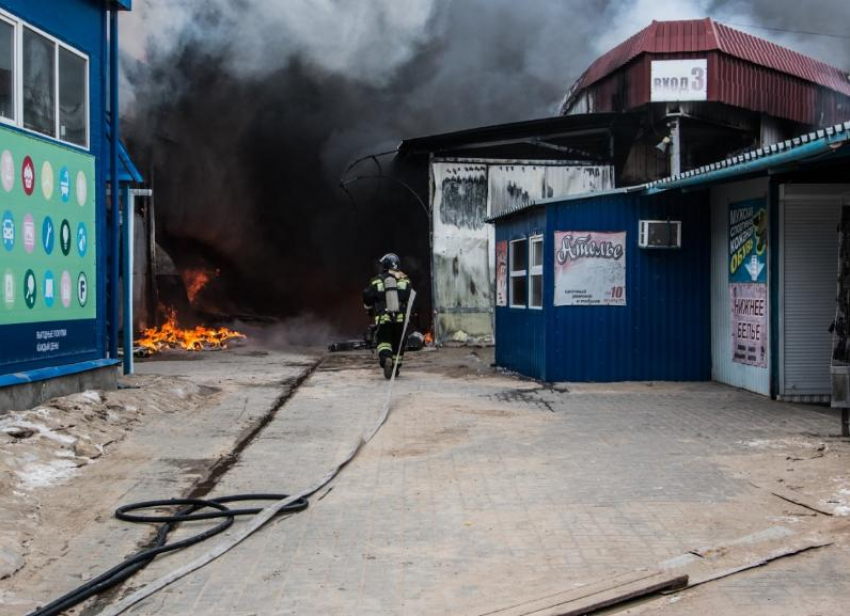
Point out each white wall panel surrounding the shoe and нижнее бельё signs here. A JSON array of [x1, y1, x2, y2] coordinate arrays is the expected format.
[[711, 178, 774, 396]]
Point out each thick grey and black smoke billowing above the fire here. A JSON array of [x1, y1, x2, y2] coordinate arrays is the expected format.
[[121, 0, 850, 328]]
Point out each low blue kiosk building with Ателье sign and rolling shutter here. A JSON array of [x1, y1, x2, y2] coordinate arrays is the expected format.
[[490, 122, 850, 401]]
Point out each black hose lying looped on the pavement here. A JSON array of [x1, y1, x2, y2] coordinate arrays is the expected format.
[[27, 494, 308, 616]]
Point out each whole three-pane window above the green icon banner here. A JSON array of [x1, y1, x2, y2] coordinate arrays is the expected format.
[[0, 10, 89, 147]]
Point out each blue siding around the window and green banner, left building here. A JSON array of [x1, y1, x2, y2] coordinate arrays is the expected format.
[[0, 0, 109, 369]]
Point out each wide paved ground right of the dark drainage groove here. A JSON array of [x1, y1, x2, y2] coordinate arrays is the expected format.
[[88, 349, 850, 616]]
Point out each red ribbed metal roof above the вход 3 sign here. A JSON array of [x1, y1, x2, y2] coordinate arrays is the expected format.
[[571, 18, 850, 96]]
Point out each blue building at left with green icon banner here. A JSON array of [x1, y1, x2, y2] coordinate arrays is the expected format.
[[0, 0, 137, 412]]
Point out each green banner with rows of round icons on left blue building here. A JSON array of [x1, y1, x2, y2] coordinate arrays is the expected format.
[[0, 122, 97, 370]]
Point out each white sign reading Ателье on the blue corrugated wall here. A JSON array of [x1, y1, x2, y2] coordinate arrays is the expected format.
[[555, 231, 626, 306]]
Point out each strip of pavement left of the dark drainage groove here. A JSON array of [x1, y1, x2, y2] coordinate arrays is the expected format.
[[0, 349, 317, 616]]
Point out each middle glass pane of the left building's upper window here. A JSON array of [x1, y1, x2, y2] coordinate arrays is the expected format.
[[23, 28, 56, 137]]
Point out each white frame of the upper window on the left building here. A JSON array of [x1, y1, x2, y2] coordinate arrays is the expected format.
[[0, 9, 91, 151]]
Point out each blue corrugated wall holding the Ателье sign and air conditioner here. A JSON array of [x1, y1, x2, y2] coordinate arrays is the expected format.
[[543, 192, 711, 381]]
